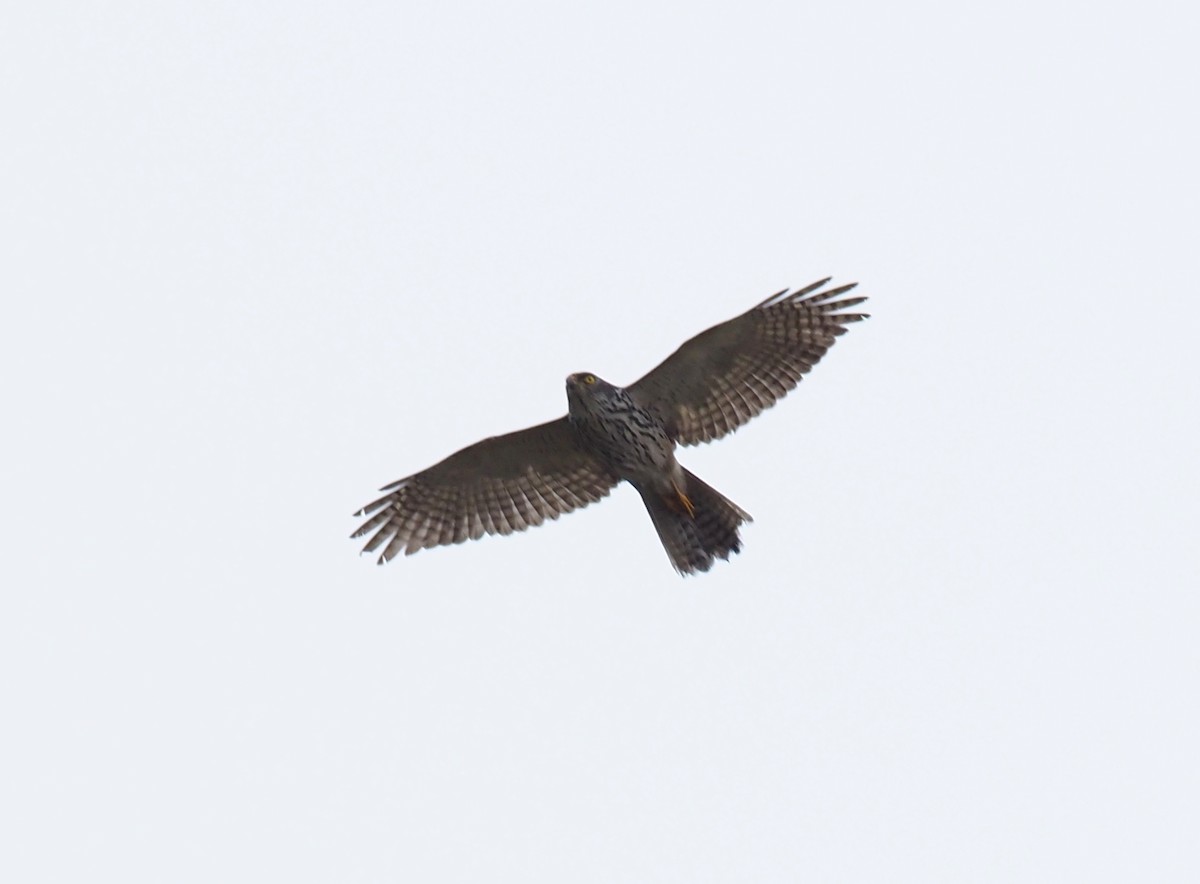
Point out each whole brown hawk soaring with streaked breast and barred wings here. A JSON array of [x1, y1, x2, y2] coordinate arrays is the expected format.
[[352, 279, 866, 575]]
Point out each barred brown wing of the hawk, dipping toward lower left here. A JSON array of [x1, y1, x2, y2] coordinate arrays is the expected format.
[[350, 417, 618, 565]]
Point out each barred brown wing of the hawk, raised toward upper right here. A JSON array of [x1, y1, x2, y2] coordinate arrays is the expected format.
[[629, 279, 866, 445]]
